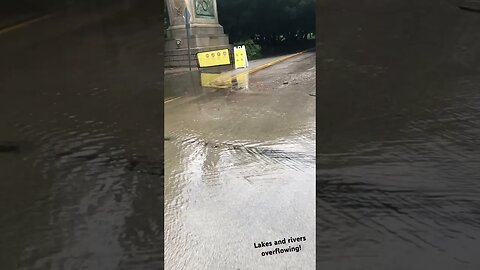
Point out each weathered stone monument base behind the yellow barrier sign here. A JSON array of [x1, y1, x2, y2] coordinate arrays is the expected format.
[[165, 0, 230, 67]]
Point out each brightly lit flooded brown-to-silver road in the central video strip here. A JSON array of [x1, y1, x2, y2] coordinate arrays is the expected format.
[[165, 52, 315, 269]]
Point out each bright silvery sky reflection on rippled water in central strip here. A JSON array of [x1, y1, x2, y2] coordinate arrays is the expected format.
[[165, 130, 315, 269]]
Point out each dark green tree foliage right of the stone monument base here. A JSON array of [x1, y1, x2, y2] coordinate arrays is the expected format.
[[217, 0, 315, 45]]
